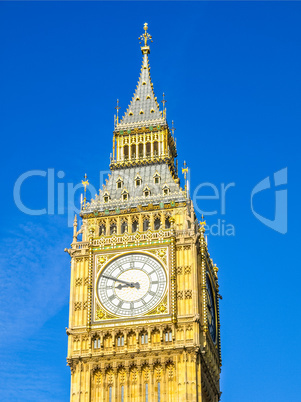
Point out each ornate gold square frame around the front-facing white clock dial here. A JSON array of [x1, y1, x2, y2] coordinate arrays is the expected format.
[[92, 246, 170, 324]]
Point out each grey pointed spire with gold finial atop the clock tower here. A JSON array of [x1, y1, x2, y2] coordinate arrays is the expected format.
[[118, 23, 165, 129]]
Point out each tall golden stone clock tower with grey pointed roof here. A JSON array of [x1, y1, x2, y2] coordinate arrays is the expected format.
[[67, 24, 221, 402]]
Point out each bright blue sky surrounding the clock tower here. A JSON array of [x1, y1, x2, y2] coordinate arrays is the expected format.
[[0, 2, 301, 402]]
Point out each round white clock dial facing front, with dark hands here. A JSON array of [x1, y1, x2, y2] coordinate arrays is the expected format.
[[97, 253, 166, 317]]
